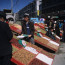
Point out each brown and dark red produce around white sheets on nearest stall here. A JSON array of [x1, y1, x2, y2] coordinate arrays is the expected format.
[[12, 43, 54, 65]]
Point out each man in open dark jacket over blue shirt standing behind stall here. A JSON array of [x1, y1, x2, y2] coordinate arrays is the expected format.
[[21, 15, 35, 44]]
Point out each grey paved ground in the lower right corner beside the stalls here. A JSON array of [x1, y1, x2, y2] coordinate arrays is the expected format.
[[53, 43, 65, 65]]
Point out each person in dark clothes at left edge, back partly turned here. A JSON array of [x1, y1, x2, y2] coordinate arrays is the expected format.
[[0, 11, 13, 65]]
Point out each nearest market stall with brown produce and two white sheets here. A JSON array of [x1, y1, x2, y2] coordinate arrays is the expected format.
[[11, 40, 55, 65]]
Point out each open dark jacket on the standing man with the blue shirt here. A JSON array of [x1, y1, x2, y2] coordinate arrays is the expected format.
[[21, 20, 35, 37]]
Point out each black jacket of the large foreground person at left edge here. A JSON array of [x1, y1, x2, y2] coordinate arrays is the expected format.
[[0, 21, 13, 56]]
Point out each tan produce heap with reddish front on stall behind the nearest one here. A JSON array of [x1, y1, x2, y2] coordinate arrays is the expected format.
[[34, 35, 59, 51]]
